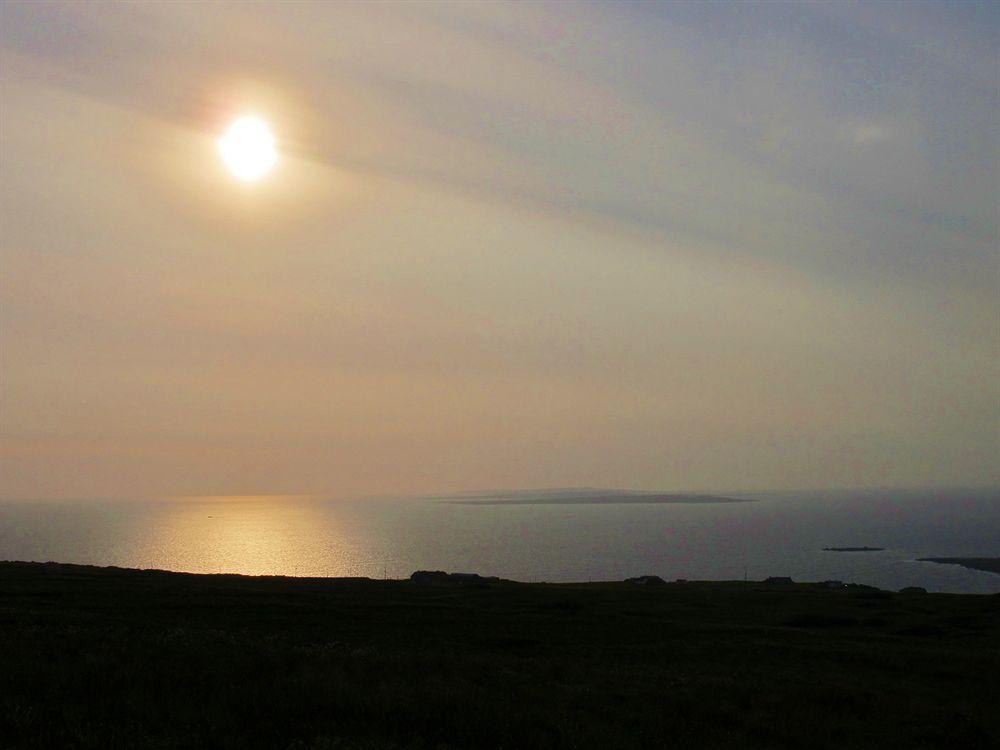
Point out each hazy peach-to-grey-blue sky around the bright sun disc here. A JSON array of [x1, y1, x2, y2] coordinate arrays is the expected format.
[[0, 1, 1000, 497]]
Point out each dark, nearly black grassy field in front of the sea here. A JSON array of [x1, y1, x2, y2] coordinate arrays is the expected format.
[[0, 563, 1000, 750]]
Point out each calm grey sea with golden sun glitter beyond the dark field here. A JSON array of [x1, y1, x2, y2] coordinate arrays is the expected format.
[[0, 490, 1000, 594]]
